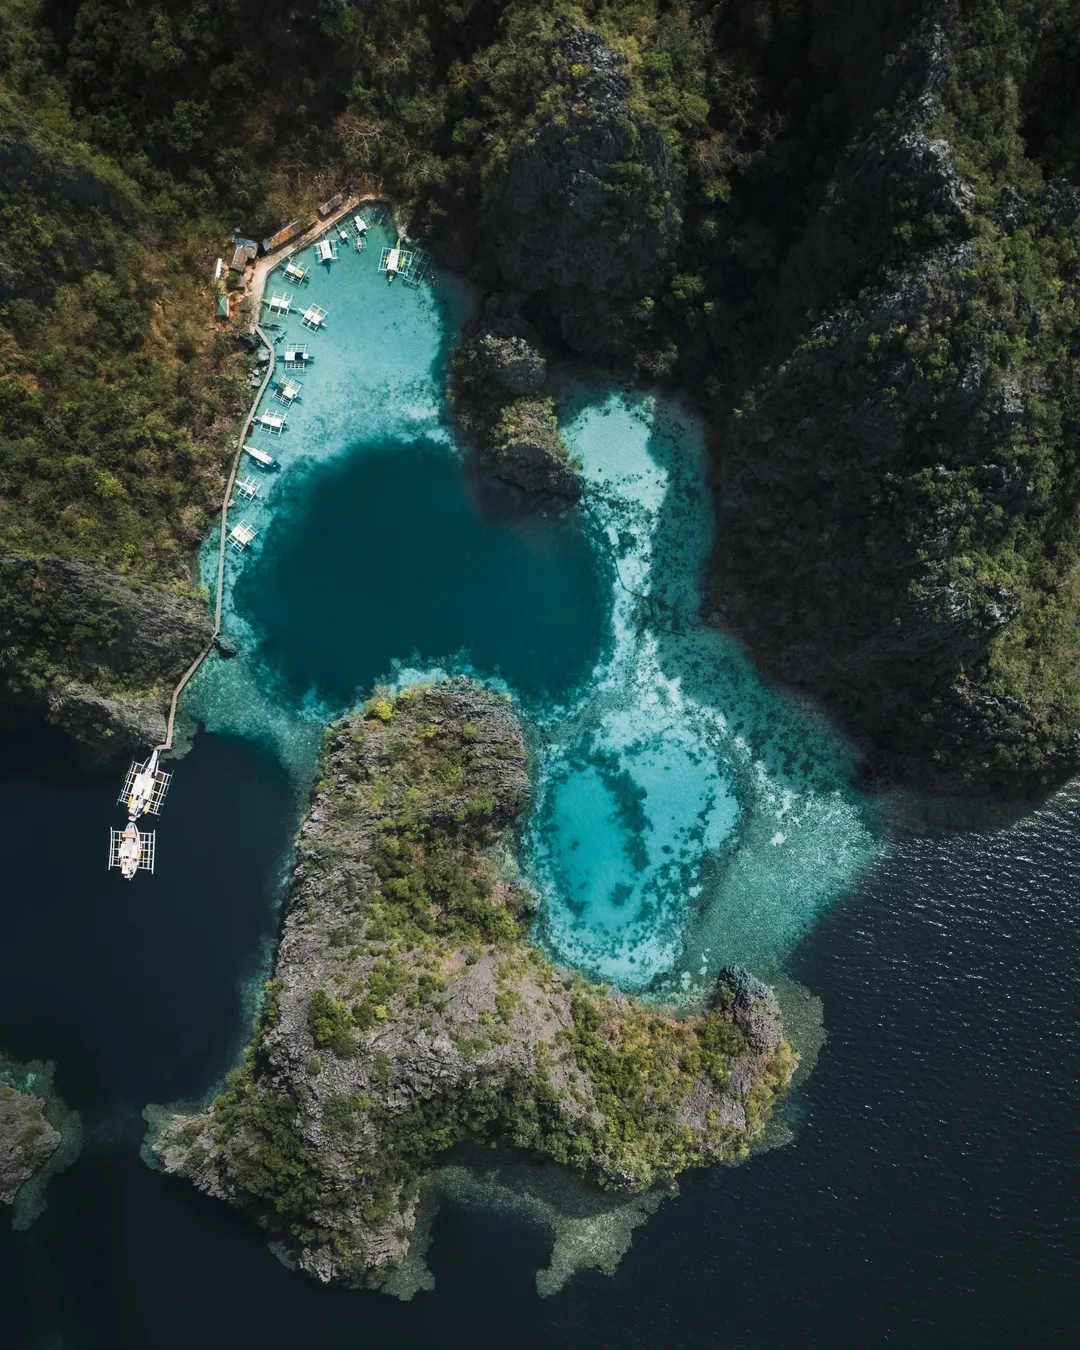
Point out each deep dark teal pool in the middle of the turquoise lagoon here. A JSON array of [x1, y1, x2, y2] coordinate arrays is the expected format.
[[234, 439, 612, 709]]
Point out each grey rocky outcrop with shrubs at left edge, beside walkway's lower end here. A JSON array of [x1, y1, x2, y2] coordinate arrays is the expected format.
[[0, 558, 212, 757]]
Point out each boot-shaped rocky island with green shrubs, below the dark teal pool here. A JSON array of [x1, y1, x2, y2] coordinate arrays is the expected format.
[[154, 680, 794, 1284]]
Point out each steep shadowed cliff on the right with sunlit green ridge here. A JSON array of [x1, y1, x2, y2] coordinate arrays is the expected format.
[[707, 15, 1080, 795]]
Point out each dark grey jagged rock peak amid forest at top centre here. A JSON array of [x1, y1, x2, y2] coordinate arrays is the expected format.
[[489, 20, 679, 352]]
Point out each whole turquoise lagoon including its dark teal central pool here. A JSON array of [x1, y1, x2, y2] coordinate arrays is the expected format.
[[185, 221, 875, 1000]]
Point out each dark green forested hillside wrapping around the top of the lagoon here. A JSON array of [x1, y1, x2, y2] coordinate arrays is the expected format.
[[0, 0, 1080, 791]]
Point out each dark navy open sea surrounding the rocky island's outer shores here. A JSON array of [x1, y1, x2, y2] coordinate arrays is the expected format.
[[0, 724, 1080, 1350]]
